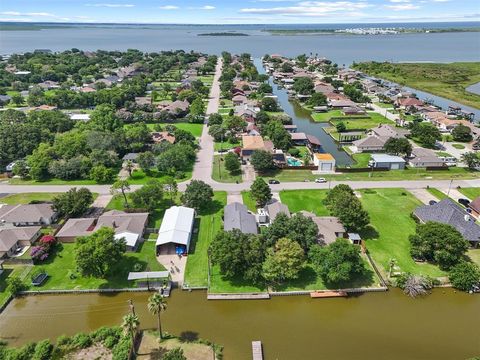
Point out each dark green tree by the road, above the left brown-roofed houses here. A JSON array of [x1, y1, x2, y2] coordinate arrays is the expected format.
[[52, 188, 93, 217]]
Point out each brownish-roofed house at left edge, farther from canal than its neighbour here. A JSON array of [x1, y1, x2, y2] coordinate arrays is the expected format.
[[0, 204, 57, 226]]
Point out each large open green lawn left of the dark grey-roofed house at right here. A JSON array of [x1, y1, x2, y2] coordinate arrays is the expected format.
[[360, 189, 445, 277]]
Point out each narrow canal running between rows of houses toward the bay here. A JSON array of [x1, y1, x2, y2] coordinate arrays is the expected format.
[[254, 59, 354, 165]]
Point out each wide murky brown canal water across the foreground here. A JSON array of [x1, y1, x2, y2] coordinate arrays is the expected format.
[[0, 289, 480, 360]]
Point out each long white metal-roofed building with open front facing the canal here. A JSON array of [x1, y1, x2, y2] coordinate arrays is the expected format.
[[155, 206, 195, 255]]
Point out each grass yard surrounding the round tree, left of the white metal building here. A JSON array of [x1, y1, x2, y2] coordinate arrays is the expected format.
[[26, 241, 165, 290]]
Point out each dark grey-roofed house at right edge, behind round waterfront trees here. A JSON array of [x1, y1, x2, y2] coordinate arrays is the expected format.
[[413, 198, 480, 247]]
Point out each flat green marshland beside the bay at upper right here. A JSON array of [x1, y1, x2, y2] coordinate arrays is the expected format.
[[357, 62, 480, 109]]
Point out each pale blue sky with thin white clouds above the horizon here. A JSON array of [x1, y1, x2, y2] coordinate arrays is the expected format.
[[0, 0, 480, 24]]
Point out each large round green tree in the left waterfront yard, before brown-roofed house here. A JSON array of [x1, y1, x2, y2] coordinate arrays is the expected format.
[[75, 227, 125, 278]]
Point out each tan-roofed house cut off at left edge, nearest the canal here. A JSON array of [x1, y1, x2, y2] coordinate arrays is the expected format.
[[0, 226, 42, 259]]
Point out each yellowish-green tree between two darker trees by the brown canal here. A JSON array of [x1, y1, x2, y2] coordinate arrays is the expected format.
[[263, 238, 304, 283]]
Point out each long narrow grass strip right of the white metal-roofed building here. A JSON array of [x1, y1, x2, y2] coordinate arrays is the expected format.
[[185, 191, 227, 287]]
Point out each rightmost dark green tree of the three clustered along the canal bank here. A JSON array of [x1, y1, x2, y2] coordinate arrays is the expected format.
[[308, 239, 365, 284]]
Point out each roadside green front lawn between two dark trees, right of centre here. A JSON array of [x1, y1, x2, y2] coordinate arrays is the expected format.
[[280, 190, 329, 216]]
